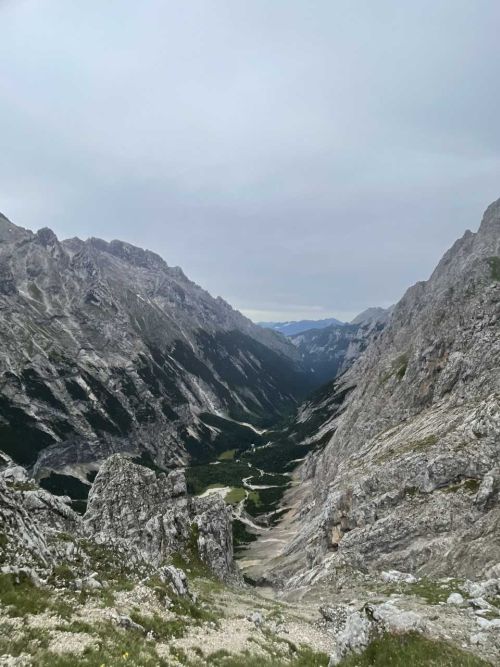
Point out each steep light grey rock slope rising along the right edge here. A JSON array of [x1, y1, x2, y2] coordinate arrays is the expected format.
[[275, 200, 500, 581]]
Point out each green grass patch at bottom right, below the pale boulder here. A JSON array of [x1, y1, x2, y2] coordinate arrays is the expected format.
[[339, 633, 490, 667]]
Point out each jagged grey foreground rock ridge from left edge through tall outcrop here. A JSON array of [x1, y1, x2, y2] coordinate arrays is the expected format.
[[0, 454, 238, 580]]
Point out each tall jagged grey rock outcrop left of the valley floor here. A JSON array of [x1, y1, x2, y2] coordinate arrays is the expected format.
[[83, 454, 236, 579]]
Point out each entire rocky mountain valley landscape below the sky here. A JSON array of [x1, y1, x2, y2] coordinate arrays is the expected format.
[[0, 200, 500, 667]]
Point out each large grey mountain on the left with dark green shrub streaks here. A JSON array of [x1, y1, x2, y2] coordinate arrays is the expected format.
[[0, 211, 312, 495]]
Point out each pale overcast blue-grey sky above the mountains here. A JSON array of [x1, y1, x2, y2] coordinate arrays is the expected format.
[[0, 0, 500, 321]]
